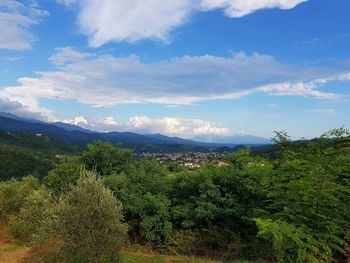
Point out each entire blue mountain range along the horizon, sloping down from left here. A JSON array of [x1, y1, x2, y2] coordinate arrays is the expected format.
[[0, 112, 270, 147]]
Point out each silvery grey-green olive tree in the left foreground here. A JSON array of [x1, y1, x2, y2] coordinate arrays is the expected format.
[[44, 171, 126, 263]]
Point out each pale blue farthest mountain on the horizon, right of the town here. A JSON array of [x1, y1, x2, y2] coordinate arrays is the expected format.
[[193, 134, 271, 145]]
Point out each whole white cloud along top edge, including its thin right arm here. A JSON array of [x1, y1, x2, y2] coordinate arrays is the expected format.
[[57, 0, 306, 47]]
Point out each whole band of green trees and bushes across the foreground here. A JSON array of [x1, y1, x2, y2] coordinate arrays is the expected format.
[[0, 128, 350, 263]]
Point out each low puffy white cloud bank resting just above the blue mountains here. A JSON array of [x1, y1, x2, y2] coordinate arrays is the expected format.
[[64, 116, 230, 138]]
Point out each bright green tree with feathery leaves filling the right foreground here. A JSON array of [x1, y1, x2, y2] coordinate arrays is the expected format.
[[255, 135, 350, 262]]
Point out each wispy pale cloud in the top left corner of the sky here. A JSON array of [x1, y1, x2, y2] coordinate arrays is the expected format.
[[0, 0, 48, 50]]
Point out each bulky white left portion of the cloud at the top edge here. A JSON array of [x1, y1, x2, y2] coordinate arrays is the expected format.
[[61, 0, 193, 47]]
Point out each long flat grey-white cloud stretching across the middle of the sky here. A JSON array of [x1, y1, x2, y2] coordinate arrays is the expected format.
[[3, 49, 345, 109]]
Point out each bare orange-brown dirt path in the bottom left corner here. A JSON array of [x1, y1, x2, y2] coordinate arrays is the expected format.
[[0, 240, 30, 263]]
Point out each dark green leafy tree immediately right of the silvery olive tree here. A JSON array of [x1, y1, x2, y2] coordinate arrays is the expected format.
[[104, 160, 172, 249]]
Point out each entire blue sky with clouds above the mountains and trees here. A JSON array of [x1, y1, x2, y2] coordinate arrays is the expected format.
[[0, 0, 350, 139]]
